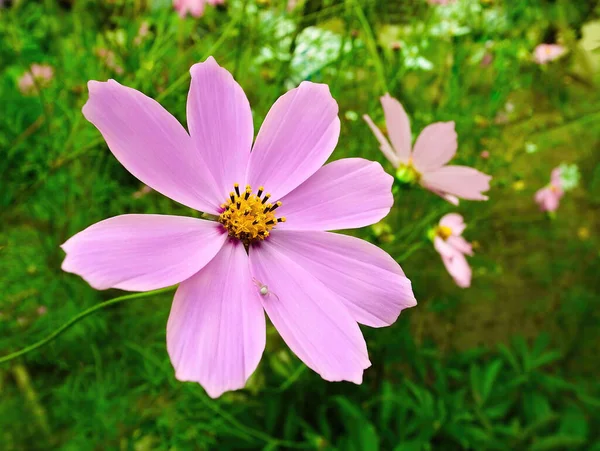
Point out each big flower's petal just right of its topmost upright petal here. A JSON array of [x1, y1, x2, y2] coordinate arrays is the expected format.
[[247, 81, 340, 200]]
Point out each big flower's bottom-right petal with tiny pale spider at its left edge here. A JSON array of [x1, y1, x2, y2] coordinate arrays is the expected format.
[[250, 240, 371, 384]]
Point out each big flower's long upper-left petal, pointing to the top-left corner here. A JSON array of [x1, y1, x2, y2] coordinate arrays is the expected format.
[[83, 80, 223, 213]]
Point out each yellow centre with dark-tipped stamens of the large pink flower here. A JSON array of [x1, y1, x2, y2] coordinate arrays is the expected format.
[[219, 183, 285, 246]]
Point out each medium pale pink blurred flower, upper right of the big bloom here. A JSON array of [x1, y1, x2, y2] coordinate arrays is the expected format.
[[363, 94, 492, 205]]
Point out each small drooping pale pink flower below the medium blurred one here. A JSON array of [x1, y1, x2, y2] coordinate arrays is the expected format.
[[433, 213, 473, 288]]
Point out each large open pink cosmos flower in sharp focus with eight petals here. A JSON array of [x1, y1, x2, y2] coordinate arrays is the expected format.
[[62, 57, 416, 397]]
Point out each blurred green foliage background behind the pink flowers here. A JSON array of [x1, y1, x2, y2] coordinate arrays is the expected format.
[[0, 0, 600, 451]]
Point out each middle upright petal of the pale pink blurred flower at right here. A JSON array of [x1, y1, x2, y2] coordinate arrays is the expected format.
[[413, 122, 458, 173]]
